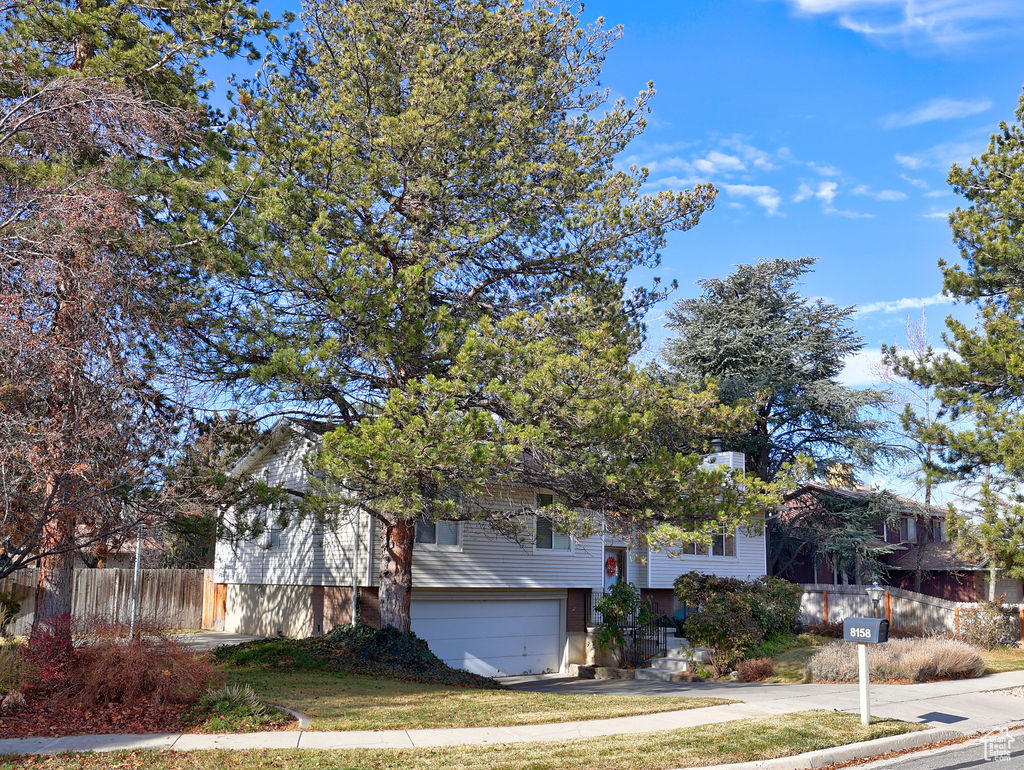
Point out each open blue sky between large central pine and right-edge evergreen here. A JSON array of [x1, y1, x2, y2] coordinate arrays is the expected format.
[[573, 0, 1024, 384]]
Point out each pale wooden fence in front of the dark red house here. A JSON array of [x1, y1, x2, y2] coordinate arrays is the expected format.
[[800, 583, 1024, 642]]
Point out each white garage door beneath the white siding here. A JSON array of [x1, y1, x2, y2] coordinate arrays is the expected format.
[[410, 598, 562, 677]]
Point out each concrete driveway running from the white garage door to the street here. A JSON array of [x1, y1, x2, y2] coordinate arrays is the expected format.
[[503, 671, 1024, 733]]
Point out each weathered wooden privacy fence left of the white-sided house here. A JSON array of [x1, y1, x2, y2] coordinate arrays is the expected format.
[[0, 568, 226, 636]]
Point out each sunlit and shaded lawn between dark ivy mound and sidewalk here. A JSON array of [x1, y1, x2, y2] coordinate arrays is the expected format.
[[224, 667, 732, 730]]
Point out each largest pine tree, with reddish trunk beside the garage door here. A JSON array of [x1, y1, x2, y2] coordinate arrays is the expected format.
[[205, 0, 782, 630]]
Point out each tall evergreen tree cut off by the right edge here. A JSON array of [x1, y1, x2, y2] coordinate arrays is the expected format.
[[896, 95, 1024, 593]]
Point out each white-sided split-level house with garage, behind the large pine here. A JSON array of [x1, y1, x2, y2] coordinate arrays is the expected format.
[[214, 420, 765, 675]]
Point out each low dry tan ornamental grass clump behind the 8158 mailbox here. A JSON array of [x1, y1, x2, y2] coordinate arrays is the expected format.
[[807, 639, 985, 682]]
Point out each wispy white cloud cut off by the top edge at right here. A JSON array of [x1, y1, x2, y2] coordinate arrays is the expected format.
[[785, 0, 1024, 48]]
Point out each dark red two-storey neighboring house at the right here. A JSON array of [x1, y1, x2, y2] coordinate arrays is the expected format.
[[771, 482, 1021, 602]]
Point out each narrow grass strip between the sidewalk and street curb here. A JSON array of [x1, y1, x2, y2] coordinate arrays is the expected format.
[[0, 712, 924, 770]]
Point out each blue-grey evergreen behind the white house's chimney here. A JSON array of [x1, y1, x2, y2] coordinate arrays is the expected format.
[[663, 258, 885, 480]]
